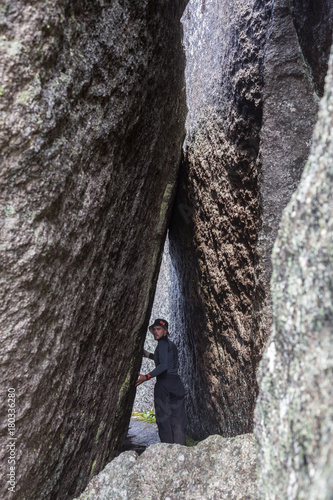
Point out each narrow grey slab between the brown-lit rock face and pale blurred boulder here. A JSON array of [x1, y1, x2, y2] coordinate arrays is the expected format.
[[256, 0, 320, 348]]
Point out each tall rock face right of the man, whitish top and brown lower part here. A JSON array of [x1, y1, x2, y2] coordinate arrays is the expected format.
[[170, 0, 271, 438]]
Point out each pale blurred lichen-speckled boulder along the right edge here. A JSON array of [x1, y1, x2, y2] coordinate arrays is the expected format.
[[256, 47, 333, 500]]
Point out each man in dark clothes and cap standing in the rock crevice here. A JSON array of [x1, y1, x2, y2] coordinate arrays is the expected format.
[[135, 319, 186, 445]]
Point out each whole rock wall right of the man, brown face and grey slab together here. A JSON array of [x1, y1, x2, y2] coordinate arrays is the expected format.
[[166, 0, 332, 438]]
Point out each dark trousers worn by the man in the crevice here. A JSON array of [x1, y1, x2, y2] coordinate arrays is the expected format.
[[154, 374, 186, 445]]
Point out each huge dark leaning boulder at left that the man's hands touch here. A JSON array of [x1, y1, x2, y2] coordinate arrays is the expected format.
[[0, 0, 186, 500]]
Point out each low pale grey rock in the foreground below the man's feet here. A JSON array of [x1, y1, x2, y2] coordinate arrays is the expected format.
[[76, 434, 257, 500]]
